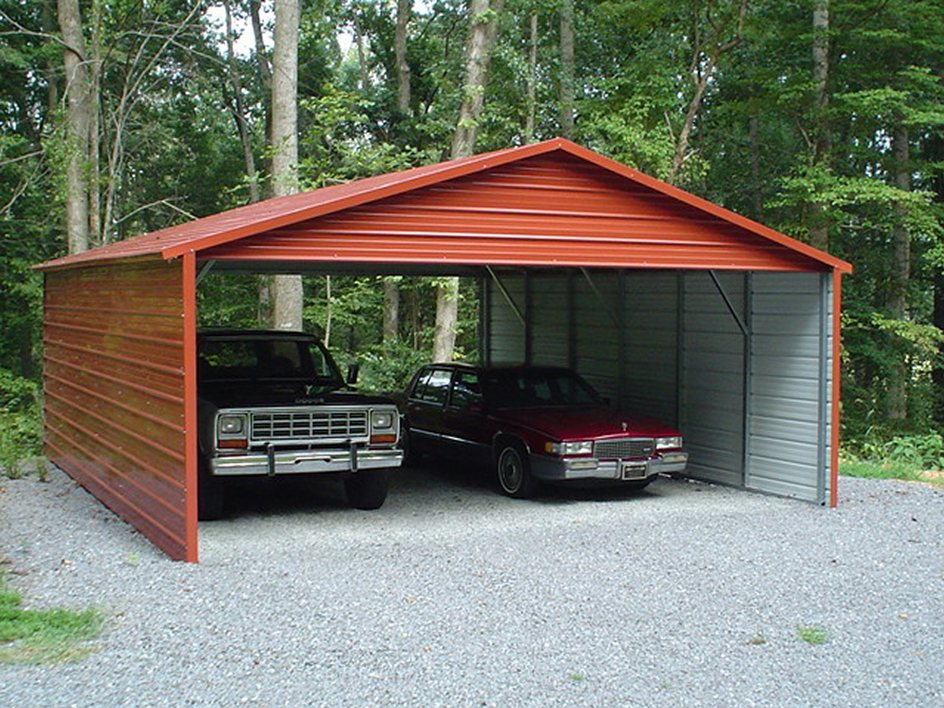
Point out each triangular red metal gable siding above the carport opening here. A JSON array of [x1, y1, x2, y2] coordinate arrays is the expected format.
[[201, 155, 824, 271]]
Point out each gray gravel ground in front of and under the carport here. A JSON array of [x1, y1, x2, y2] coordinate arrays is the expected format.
[[0, 469, 944, 707]]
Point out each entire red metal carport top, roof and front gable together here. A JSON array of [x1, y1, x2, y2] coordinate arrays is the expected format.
[[39, 138, 851, 272]]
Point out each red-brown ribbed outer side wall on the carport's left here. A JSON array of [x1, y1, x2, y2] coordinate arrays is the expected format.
[[43, 259, 187, 559]]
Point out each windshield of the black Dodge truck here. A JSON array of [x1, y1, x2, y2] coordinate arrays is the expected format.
[[197, 339, 342, 386]]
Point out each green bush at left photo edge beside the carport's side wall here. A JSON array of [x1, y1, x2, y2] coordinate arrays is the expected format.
[[0, 368, 43, 477]]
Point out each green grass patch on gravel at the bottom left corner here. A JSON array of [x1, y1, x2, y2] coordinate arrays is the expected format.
[[0, 578, 102, 664]]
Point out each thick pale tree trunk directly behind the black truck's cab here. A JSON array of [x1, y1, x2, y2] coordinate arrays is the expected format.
[[272, 0, 303, 330]]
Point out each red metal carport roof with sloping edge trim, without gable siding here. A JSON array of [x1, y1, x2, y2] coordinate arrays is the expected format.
[[37, 138, 852, 273]]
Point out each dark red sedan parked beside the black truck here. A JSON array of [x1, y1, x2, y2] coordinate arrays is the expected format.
[[402, 364, 688, 498]]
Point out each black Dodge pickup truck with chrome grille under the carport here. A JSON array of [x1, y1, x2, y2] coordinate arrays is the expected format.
[[197, 329, 403, 519]]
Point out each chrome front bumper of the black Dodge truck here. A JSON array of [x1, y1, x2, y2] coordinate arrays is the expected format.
[[210, 449, 403, 477]]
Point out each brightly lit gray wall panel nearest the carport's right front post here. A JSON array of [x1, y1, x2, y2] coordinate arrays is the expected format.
[[746, 273, 825, 501]]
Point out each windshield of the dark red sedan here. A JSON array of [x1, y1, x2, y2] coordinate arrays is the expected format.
[[483, 370, 601, 408]]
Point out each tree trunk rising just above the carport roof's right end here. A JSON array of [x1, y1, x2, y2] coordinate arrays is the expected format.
[[809, 0, 832, 250]]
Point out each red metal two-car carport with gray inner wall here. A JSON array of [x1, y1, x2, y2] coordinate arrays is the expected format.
[[38, 139, 851, 561]]
